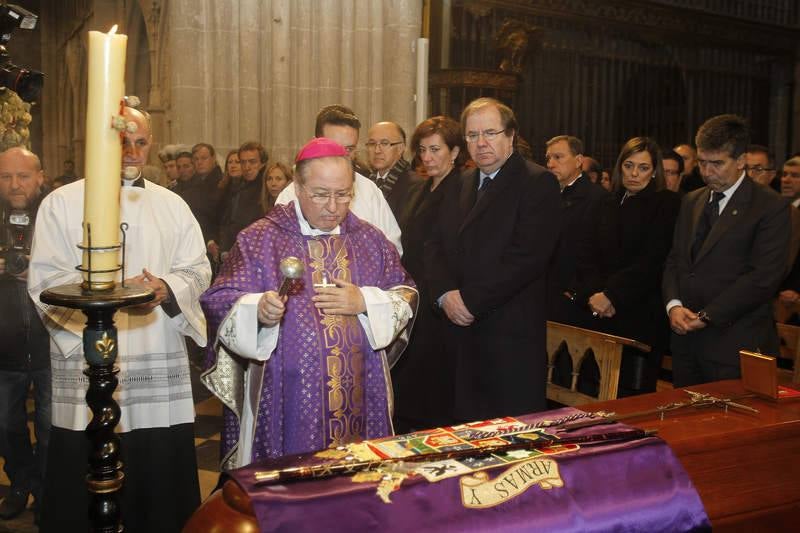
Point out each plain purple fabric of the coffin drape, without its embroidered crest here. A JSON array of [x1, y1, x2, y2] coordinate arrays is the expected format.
[[230, 408, 711, 533]]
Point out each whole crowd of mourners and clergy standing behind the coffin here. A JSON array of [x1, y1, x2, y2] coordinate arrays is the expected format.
[[0, 98, 800, 531]]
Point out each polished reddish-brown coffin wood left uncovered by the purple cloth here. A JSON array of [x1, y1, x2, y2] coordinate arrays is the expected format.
[[185, 381, 800, 533]]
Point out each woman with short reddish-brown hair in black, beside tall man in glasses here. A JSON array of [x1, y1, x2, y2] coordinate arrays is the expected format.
[[392, 116, 466, 433]]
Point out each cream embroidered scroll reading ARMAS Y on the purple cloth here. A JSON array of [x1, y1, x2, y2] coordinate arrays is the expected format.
[[459, 458, 564, 509]]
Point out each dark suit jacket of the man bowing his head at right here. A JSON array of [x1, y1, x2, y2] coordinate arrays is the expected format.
[[663, 179, 791, 366]]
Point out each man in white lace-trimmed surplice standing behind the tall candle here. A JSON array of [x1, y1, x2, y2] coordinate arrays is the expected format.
[[28, 108, 211, 531]]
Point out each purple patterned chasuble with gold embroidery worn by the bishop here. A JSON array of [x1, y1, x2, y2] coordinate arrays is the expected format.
[[201, 204, 414, 460]]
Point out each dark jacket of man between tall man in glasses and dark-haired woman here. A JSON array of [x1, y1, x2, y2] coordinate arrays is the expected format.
[[547, 172, 618, 327]]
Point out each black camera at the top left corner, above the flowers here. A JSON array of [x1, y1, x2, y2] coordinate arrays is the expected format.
[[0, 3, 44, 102]]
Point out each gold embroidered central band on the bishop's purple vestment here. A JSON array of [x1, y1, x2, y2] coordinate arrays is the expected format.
[[308, 235, 365, 446]]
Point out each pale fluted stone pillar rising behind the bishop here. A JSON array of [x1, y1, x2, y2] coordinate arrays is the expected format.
[[166, 0, 422, 162]]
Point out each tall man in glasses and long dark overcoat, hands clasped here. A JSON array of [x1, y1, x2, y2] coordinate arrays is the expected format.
[[425, 98, 561, 421]]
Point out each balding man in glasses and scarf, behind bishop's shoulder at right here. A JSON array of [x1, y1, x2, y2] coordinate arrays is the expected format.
[[366, 122, 412, 219]]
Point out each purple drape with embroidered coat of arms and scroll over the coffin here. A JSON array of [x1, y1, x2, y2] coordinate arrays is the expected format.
[[223, 408, 710, 533]]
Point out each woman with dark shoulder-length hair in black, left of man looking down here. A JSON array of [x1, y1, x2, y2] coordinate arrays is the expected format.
[[589, 137, 680, 396]]
